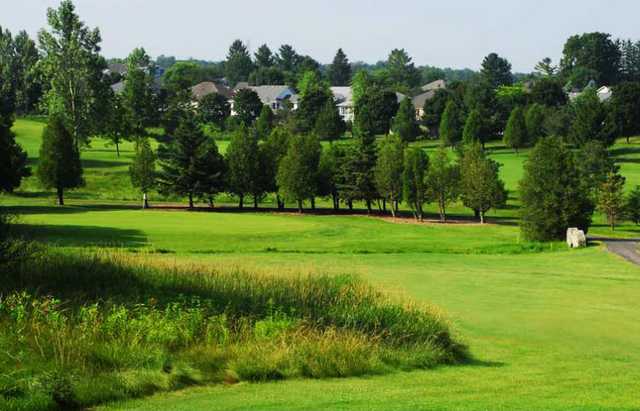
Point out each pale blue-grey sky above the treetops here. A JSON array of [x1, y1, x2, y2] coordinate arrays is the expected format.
[[5, 0, 640, 72]]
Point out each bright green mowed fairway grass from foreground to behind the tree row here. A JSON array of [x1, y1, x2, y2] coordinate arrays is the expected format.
[[1, 121, 640, 411]]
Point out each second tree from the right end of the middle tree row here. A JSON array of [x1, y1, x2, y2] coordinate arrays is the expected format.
[[425, 147, 460, 223]]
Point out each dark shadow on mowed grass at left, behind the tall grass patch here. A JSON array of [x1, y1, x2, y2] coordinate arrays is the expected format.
[[14, 224, 147, 249]]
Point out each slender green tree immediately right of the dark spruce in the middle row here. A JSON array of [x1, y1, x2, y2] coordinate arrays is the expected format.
[[226, 125, 263, 209]]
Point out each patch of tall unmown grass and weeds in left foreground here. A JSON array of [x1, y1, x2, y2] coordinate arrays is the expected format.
[[0, 250, 467, 410]]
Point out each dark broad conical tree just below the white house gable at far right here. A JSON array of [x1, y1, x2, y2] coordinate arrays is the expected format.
[[569, 89, 615, 146]]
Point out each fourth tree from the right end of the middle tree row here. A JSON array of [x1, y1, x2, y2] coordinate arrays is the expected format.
[[375, 134, 404, 217]]
